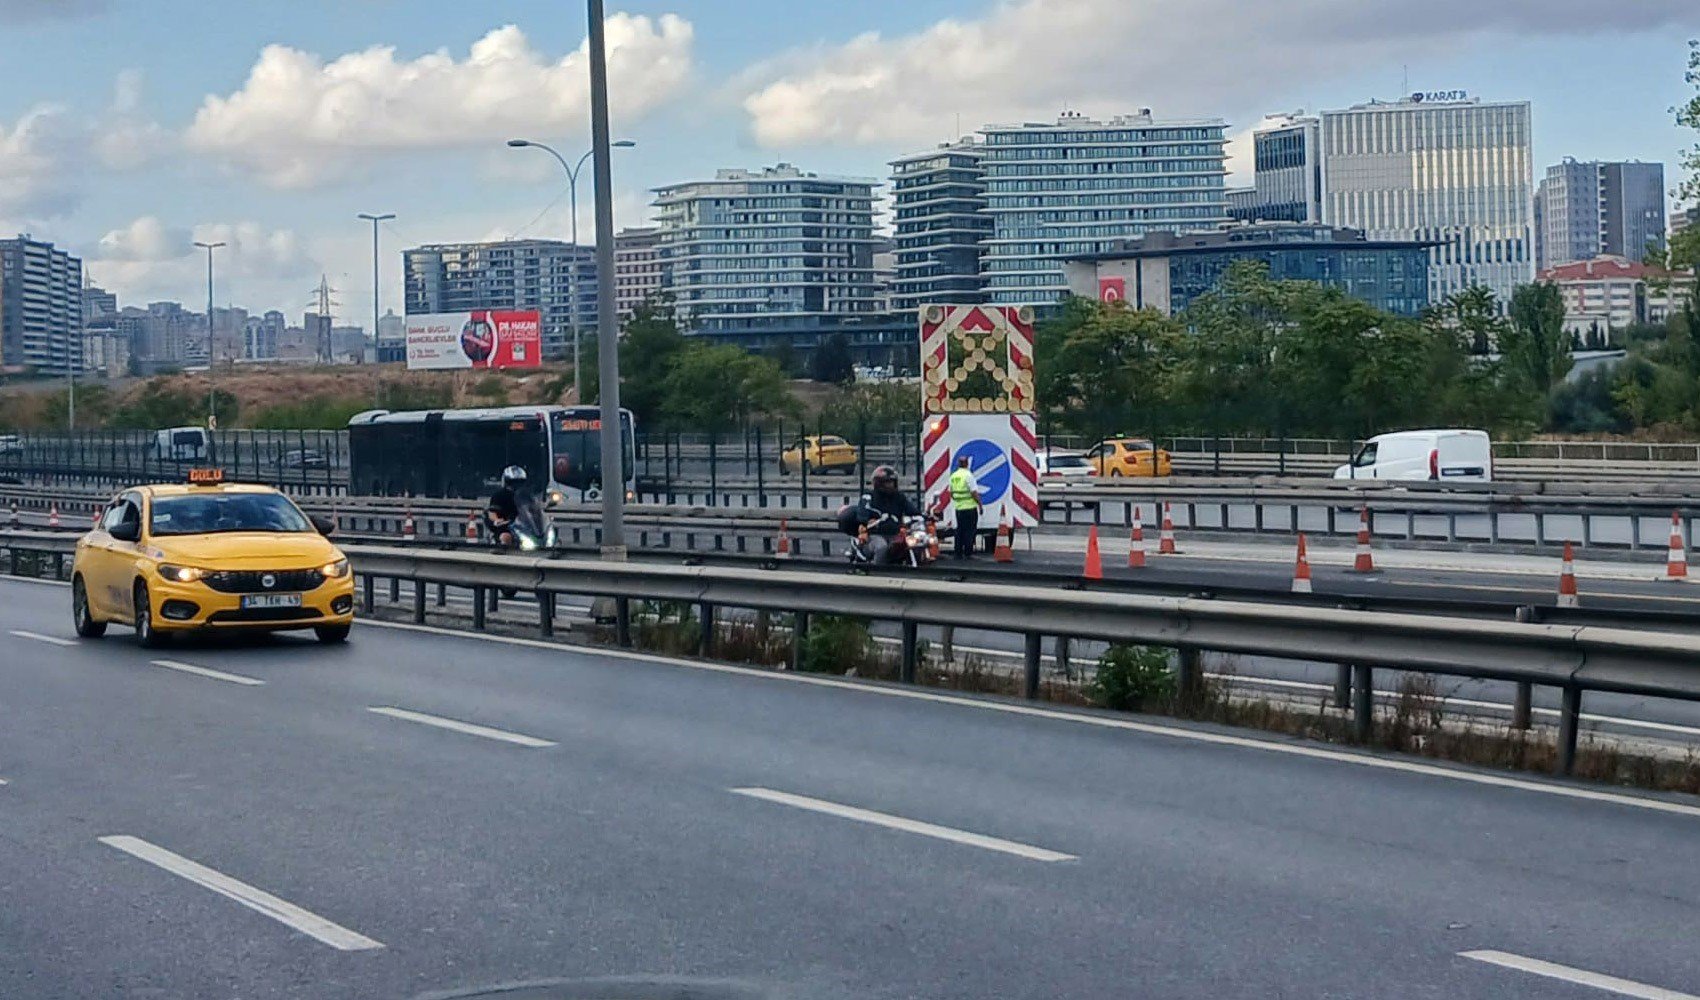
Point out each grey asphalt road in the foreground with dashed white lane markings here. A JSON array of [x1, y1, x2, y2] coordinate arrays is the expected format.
[[0, 582, 1700, 1000]]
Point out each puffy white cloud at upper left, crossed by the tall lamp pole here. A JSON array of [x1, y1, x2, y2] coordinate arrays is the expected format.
[[187, 14, 694, 187]]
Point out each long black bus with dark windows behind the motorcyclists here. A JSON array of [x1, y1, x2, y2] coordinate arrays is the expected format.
[[349, 406, 638, 503]]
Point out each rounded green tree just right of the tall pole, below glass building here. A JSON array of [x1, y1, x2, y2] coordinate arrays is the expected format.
[[661, 342, 796, 432]]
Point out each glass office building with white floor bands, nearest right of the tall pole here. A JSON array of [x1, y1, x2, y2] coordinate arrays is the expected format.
[[655, 163, 916, 362]]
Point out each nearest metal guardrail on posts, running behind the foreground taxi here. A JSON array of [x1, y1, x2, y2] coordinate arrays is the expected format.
[[0, 531, 1700, 774]]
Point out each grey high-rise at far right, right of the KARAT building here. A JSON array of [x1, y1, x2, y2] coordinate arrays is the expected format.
[[1535, 158, 1664, 270]]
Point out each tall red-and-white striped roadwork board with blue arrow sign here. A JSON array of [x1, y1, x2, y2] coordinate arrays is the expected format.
[[921, 304, 1039, 527]]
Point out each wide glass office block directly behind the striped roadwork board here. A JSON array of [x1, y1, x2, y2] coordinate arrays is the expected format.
[[981, 109, 1229, 310]]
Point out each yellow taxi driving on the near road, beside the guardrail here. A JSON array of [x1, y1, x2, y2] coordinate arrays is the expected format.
[[71, 469, 354, 646]]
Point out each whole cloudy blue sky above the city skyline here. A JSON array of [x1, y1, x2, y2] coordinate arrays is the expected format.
[[0, 0, 1700, 321]]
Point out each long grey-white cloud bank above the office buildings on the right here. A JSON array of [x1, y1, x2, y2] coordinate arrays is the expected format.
[[743, 0, 1700, 146]]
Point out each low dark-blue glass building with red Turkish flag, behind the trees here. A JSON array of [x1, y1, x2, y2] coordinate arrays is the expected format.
[[1063, 223, 1431, 316]]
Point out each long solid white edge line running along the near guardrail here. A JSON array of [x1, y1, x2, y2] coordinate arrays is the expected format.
[[366, 621, 1700, 818]]
